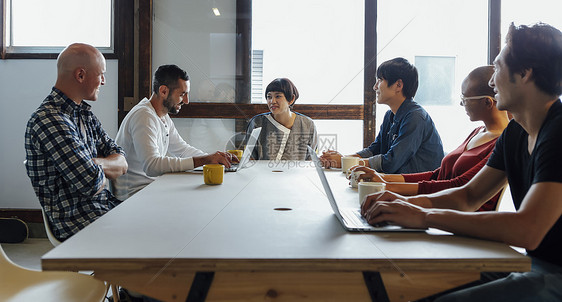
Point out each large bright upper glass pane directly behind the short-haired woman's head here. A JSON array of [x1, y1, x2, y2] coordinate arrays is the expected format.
[[252, 0, 365, 104]]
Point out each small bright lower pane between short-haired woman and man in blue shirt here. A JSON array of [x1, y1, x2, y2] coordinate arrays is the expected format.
[[314, 120, 363, 155]]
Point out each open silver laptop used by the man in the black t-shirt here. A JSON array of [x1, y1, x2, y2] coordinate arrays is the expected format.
[[308, 147, 425, 232]]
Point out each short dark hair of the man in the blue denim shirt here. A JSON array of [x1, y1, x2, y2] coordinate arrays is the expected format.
[[377, 58, 419, 99]]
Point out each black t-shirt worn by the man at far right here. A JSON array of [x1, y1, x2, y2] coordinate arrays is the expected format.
[[488, 100, 562, 266]]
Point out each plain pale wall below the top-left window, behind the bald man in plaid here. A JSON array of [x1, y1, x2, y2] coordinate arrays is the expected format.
[[0, 60, 117, 209]]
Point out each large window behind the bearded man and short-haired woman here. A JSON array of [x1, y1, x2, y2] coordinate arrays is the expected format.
[[152, 0, 365, 152]]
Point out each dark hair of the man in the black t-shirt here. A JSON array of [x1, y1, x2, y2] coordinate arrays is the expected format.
[[505, 23, 562, 96]]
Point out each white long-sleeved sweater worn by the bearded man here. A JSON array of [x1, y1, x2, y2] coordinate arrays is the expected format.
[[113, 98, 206, 200]]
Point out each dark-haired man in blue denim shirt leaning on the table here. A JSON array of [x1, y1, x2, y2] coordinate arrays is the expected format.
[[320, 58, 443, 174]]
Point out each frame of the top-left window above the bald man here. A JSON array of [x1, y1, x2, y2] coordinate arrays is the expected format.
[[0, 0, 118, 60]]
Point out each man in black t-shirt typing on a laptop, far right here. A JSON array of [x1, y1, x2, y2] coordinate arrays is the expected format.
[[361, 23, 562, 302]]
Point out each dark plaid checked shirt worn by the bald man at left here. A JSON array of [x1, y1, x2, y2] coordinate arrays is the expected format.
[[25, 87, 125, 240]]
